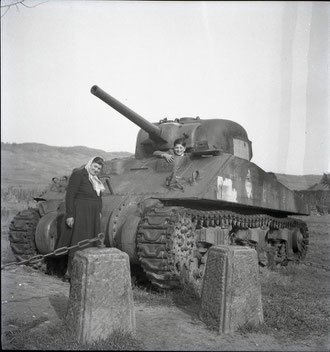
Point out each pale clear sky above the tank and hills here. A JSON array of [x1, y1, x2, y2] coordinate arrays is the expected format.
[[1, 0, 330, 175]]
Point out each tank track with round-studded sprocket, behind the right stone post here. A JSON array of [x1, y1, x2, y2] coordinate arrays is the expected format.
[[137, 206, 309, 292]]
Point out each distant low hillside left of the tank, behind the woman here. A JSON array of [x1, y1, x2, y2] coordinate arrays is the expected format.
[[1, 142, 132, 188]]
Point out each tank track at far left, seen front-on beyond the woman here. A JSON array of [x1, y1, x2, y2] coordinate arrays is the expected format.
[[9, 208, 40, 261]]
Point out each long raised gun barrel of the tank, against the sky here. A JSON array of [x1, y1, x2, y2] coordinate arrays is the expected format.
[[91, 85, 161, 139]]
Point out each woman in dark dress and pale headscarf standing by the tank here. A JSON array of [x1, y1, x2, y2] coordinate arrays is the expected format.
[[57, 156, 105, 280]]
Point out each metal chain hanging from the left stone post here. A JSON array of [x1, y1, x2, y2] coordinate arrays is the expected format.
[[1, 232, 105, 270]]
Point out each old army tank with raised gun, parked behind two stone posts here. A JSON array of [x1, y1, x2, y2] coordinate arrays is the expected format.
[[11, 86, 308, 292]]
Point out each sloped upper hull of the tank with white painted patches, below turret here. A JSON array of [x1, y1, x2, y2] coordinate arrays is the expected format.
[[100, 153, 309, 217]]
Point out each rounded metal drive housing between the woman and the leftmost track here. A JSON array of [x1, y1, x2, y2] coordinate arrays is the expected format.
[[35, 211, 64, 254]]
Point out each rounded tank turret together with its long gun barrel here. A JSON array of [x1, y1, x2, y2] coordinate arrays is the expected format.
[[91, 86, 252, 160]]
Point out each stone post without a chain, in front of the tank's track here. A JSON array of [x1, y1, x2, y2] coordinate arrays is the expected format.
[[200, 246, 263, 334]]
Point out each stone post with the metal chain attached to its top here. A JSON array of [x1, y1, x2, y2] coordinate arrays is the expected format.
[[66, 247, 135, 343]]
